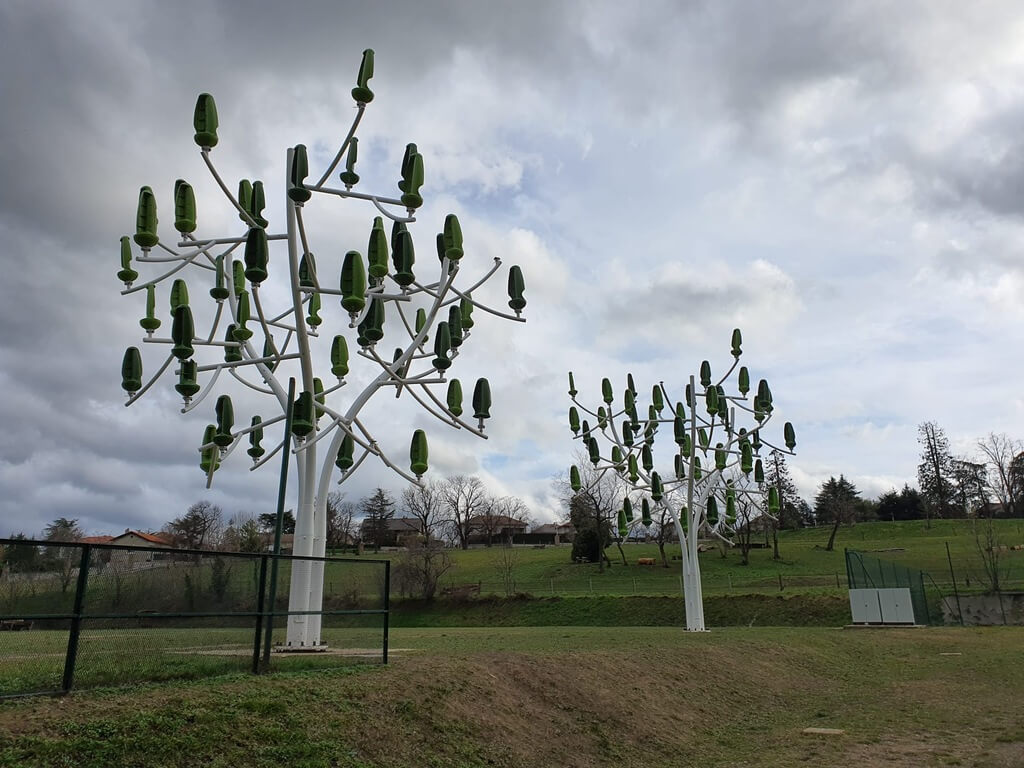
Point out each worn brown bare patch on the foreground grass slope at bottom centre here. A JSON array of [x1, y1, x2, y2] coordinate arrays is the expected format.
[[342, 648, 815, 768]]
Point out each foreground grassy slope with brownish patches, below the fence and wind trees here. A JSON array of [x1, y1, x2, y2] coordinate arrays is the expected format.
[[0, 628, 1024, 768]]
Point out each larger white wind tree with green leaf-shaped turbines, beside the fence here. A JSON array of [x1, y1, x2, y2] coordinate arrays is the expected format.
[[118, 49, 526, 648]]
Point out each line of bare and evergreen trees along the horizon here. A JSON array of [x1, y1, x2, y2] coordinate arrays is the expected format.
[[5, 422, 1024, 567]]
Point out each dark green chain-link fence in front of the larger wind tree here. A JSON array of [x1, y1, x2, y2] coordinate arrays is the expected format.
[[0, 539, 390, 698]]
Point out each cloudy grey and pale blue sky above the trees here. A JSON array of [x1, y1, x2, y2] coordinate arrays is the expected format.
[[0, 0, 1024, 535]]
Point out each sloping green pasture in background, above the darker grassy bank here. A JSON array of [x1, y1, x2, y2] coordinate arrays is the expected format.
[[6, 520, 1024, 626]]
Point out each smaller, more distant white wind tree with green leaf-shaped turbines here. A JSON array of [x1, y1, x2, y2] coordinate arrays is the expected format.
[[569, 329, 797, 631]]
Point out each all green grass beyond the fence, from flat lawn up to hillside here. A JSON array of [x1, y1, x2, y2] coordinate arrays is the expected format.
[[0, 520, 1024, 695]]
